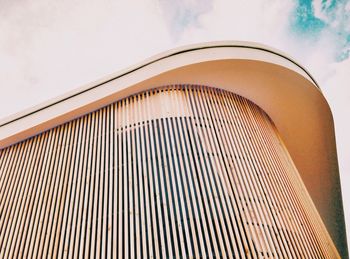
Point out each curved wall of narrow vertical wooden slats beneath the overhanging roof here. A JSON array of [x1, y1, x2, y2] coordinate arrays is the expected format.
[[0, 85, 339, 258]]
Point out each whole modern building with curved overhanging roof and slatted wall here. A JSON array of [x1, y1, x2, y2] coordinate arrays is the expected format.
[[0, 42, 347, 258]]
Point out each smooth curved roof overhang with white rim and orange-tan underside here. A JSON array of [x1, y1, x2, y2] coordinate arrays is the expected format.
[[0, 42, 343, 255]]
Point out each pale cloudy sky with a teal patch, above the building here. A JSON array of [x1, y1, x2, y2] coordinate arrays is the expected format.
[[0, 0, 350, 247]]
